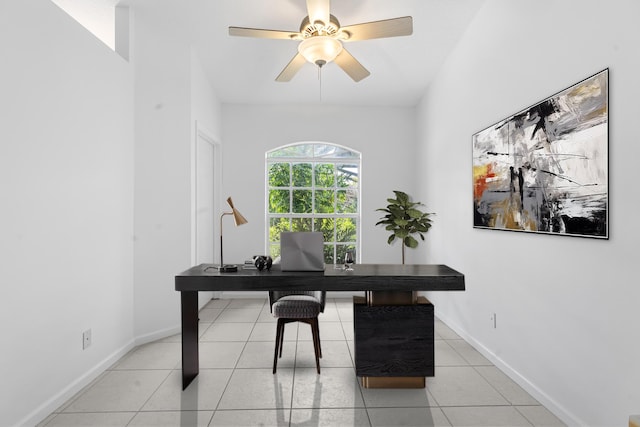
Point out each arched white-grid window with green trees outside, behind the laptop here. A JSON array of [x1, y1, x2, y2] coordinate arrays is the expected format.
[[266, 142, 360, 264]]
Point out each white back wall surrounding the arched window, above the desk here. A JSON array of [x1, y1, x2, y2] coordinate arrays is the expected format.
[[222, 104, 416, 263]]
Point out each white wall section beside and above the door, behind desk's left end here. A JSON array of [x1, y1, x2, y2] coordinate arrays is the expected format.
[[134, 0, 220, 342]]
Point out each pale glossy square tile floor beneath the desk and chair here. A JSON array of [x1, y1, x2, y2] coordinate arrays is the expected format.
[[39, 299, 564, 427]]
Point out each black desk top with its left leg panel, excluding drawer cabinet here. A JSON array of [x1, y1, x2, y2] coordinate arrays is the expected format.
[[175, 264, 465, 389]]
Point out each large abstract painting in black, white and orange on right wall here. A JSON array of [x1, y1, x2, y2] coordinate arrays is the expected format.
[[473, 69, 609, 239]]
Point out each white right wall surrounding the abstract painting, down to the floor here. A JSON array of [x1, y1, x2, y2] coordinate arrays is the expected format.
[[416, 0, 640, 426]]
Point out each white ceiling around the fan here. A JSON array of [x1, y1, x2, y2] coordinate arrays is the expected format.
[[138, 0, 484, 106]]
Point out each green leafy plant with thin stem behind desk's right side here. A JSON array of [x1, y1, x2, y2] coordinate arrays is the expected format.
[[376, 190, 435, 264]]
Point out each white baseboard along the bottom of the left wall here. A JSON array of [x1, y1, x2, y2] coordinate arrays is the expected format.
[[21, 340, 136, 427]]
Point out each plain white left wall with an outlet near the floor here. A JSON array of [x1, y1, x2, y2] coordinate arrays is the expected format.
[[0, 0, 133, 426]]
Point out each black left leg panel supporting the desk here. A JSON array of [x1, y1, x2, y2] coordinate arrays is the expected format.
[[180, 291, 200, 390]]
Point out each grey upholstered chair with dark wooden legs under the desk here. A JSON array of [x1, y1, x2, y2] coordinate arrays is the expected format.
[[269, 291, 327, 374]]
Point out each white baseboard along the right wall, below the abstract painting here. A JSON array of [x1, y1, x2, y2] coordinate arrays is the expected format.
[[435, 310, 587, 426]]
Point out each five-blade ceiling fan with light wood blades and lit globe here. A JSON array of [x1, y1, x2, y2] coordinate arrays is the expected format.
[[229, 0, 413, 82]]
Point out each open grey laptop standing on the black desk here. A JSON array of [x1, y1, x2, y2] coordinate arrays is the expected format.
[[280, 231, 324, 271]]
